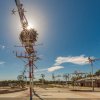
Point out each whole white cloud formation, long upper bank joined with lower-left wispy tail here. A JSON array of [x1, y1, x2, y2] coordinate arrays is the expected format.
[[36, 55, 90, 72]]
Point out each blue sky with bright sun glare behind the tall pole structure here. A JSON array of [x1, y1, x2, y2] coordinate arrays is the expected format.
[[0, 0, 100, 80]]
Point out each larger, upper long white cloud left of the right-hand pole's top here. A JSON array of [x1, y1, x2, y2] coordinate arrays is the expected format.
[[54, 55, 88, 65]]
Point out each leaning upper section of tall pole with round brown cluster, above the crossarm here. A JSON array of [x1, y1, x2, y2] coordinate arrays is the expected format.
[[15, 0, 38, 55]]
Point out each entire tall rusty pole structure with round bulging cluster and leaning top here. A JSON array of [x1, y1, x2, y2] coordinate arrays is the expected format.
[[12, 0, 38, 100]]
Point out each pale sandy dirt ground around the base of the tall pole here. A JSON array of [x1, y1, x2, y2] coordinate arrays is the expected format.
[[0, 87, 100, 100]]
